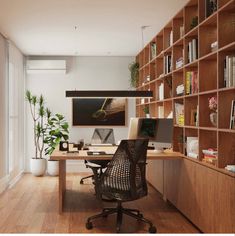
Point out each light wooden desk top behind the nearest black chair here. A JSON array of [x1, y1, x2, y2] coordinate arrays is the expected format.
[[50, 146, 183, 160]]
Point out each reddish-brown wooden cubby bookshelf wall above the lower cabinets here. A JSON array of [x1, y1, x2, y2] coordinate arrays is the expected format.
[[136, 0, 235, 177]]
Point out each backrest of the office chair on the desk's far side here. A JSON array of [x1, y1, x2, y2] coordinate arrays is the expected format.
[[91, 128, 115, 144]]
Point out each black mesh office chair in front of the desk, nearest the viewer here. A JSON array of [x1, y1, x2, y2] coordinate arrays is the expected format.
[[86, 139, 157, 233]]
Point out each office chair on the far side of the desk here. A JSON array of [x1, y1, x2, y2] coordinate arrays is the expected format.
[[80, 128, 115, 184]]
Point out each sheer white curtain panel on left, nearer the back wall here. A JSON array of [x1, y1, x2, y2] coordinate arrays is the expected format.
[[8, 42, 24, 181]]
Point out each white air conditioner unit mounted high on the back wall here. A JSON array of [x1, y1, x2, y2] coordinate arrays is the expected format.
[[26, 60, 66, 74]]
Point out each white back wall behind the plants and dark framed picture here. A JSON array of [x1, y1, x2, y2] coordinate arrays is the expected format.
[[26, 57, 135, 171]]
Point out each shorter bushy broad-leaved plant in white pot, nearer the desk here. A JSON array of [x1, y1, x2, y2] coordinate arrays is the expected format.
[[44, 114, 69, 176]]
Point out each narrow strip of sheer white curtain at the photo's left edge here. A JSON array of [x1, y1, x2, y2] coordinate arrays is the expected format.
[[0, 34, 8, 192]]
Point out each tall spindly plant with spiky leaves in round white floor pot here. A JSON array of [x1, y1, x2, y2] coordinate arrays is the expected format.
[[26, 90, 51, 176]]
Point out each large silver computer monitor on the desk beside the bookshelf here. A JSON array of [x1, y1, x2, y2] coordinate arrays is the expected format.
[[128, 118, 173, 151]]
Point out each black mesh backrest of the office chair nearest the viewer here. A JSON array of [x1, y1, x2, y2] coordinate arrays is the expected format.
[[100, 139, 148, 201]]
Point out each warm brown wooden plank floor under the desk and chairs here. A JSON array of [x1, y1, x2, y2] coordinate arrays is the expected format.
[[0, 174, 198, 233]]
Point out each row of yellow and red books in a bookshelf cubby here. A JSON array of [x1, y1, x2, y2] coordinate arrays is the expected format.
[[185, 71, 198, 95]]
